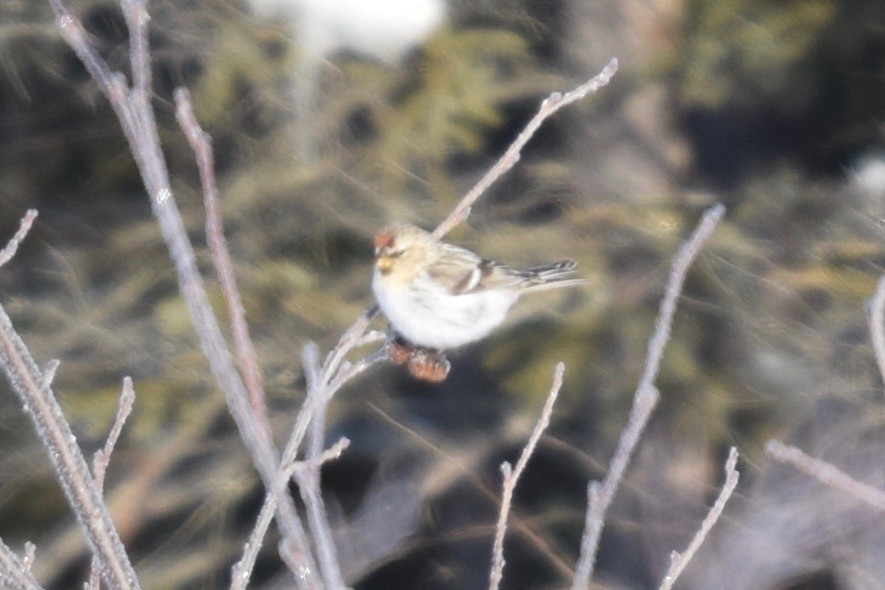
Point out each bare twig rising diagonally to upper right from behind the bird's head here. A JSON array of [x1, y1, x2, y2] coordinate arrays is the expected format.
[[433, 59, 618, 240]]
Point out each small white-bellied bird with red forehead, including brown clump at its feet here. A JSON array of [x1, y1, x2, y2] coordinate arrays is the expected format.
[[372, 223, 586, 382]]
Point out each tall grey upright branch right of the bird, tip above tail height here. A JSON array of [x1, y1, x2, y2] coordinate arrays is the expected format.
[[572, 205, 725, 590]]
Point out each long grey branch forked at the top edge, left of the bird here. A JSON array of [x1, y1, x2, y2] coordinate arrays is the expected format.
[[49, 0, 319, 589]]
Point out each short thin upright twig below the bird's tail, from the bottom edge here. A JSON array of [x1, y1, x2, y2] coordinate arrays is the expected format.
[[489, 362, 565, 590]]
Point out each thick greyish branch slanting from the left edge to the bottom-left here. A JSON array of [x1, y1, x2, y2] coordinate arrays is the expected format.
[[0, 305, 139, 589]]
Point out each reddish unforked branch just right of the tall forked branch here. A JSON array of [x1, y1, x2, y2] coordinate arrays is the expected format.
[[175, 88, 270, 431]]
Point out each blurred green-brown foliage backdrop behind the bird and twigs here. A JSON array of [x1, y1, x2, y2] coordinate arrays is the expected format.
[[0, 0, 885, 590]]
